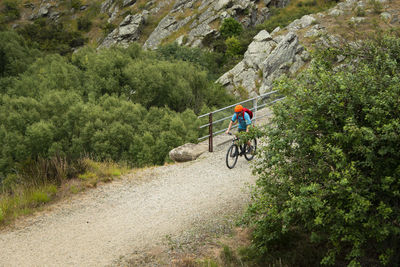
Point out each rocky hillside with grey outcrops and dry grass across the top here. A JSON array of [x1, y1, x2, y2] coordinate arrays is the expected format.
[[2, 0, 399, 96]]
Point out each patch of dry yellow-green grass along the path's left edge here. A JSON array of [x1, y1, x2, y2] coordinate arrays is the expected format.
[[0, 158, 129, 226]]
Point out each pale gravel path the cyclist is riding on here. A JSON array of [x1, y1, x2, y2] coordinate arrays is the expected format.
[[0, 141, 255, 266]]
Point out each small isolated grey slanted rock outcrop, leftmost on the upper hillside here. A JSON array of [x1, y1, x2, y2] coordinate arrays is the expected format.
[[99, 11, 148, 48]]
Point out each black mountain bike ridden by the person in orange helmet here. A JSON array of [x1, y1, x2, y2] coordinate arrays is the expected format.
[[226, 133, 257, 169]]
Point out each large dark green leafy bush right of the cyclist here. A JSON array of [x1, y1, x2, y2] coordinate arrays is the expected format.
[[249, 37, 400, 266]]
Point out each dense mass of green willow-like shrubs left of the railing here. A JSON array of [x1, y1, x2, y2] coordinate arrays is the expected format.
[[0, 32, 234, 203]]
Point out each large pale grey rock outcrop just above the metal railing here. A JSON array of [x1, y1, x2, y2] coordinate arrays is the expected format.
[[217, 25, 309, 96]]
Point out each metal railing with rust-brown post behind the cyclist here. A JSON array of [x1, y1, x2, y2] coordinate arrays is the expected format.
[[198, 91, 284, 152]]
